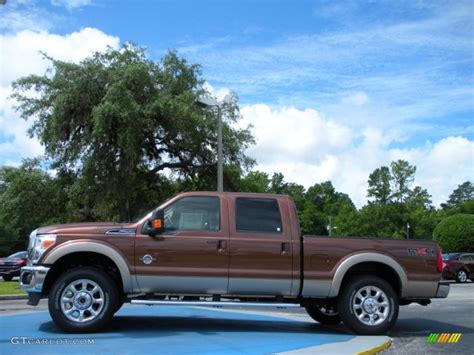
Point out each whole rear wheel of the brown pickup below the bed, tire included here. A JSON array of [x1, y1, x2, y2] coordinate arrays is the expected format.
[[338, 275, 399, 335]]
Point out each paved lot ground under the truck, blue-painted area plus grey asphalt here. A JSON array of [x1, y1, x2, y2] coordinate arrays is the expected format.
[[0, 283, 474, 354]]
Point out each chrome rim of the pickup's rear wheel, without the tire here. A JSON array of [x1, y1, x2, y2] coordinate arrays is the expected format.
[[352, 286, 390, 326]]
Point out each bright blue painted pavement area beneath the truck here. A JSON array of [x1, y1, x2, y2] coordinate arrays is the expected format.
[[0, 306, 353, 355]]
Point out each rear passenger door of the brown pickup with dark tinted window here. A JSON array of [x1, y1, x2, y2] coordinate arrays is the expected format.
[[228, 194, 295, 295]]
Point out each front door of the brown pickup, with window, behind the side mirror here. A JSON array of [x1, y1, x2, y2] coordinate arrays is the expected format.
[[135, 195, 229, 294]]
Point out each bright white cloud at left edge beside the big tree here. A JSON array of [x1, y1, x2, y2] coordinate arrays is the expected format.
[[0, 28, 119, 163]]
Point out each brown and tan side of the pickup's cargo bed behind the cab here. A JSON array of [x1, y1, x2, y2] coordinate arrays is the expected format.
[[302, 235, 440, 298]]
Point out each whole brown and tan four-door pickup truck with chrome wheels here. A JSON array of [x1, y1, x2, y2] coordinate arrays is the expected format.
[[20, 192, 449, 334]]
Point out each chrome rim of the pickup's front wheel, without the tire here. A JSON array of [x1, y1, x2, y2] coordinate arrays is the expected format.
[[60, 279, 104, 323]]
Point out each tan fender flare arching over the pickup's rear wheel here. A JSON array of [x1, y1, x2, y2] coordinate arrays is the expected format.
[[329, 252, 408, 297]]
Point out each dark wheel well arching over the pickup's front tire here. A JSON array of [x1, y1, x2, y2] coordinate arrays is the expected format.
[[43, 252, 123, 295]]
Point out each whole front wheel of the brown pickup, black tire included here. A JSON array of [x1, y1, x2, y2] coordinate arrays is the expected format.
[[48, 267, 119, 333]]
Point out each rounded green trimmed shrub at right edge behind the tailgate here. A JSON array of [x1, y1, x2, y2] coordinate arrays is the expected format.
[[433, 214, 474, 252]]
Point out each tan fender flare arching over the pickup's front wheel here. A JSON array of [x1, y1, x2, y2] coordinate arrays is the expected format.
[[42, 239, 132, 293]]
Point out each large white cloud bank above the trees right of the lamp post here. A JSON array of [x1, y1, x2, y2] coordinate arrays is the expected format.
[[239, 104, 474, 207]]
